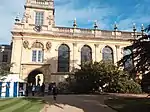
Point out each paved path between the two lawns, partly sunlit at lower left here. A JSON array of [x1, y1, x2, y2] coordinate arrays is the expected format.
[[41, 95, 116, 112]]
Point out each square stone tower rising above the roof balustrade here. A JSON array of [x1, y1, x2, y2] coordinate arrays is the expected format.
[[21, 0, 55, 31]]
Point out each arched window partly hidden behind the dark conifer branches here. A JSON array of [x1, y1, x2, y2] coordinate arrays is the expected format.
[[123, 49, 133, 70]]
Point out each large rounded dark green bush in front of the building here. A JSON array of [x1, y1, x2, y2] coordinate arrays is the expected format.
[[64, 62, 141, 93]]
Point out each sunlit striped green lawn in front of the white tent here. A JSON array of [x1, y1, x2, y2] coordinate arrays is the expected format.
[[0, 98, 44, 112]]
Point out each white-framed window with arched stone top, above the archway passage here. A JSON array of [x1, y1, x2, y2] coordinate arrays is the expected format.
[[32, 42, 44, 62]]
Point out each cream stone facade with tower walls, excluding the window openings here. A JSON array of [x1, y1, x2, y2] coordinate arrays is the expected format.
[[11, 0, 136, 82]]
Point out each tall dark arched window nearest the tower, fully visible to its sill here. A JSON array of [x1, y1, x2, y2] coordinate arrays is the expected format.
[[58, 44, 70, 72]]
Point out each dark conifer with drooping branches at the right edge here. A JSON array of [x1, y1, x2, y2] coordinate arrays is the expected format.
[[118, 25, 150, 91]]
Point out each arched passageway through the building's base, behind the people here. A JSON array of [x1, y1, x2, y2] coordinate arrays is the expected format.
[[27, 69, 44, 85]]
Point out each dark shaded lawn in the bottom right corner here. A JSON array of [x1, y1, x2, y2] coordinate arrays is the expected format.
[[105, 98, 150, 112]]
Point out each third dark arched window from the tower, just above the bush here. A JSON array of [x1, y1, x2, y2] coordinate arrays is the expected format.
[[102, 46, 114, 63]]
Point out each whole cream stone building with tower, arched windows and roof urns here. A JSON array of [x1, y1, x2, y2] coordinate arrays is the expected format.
[[11, 0, 138, 83]]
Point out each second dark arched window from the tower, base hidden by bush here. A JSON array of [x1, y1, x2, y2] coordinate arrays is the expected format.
[[81, 45, 92, 64]]
